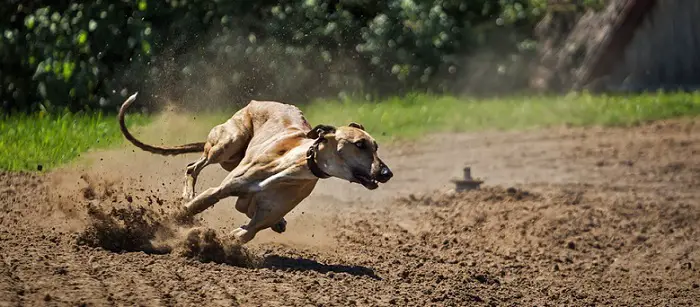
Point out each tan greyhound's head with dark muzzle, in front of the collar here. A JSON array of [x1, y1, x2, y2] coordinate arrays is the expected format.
[[307, 123, 394, 190]]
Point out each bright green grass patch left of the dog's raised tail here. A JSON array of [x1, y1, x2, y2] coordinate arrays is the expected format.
[[0, 113, 149, 171]]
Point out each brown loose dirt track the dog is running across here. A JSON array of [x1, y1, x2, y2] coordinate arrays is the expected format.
[[0, 120, 700, 306]]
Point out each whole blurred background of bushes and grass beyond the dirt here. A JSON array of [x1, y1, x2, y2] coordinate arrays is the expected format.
[[5, 0, 700, 170]]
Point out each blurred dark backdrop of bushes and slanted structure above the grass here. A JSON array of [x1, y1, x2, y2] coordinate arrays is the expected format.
[[6, 0, 688, 112]]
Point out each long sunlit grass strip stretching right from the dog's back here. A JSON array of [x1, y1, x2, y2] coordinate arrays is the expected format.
[[301, 92, 700, 141]]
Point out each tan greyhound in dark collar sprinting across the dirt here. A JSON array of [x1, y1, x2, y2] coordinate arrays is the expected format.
[[118, 93, 393, 244]]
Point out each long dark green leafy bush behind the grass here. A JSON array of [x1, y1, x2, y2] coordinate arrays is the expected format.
[[0, 0, 544, 112]]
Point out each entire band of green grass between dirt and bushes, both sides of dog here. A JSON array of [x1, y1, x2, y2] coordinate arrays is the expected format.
[[0, 93, 700, 171]]
